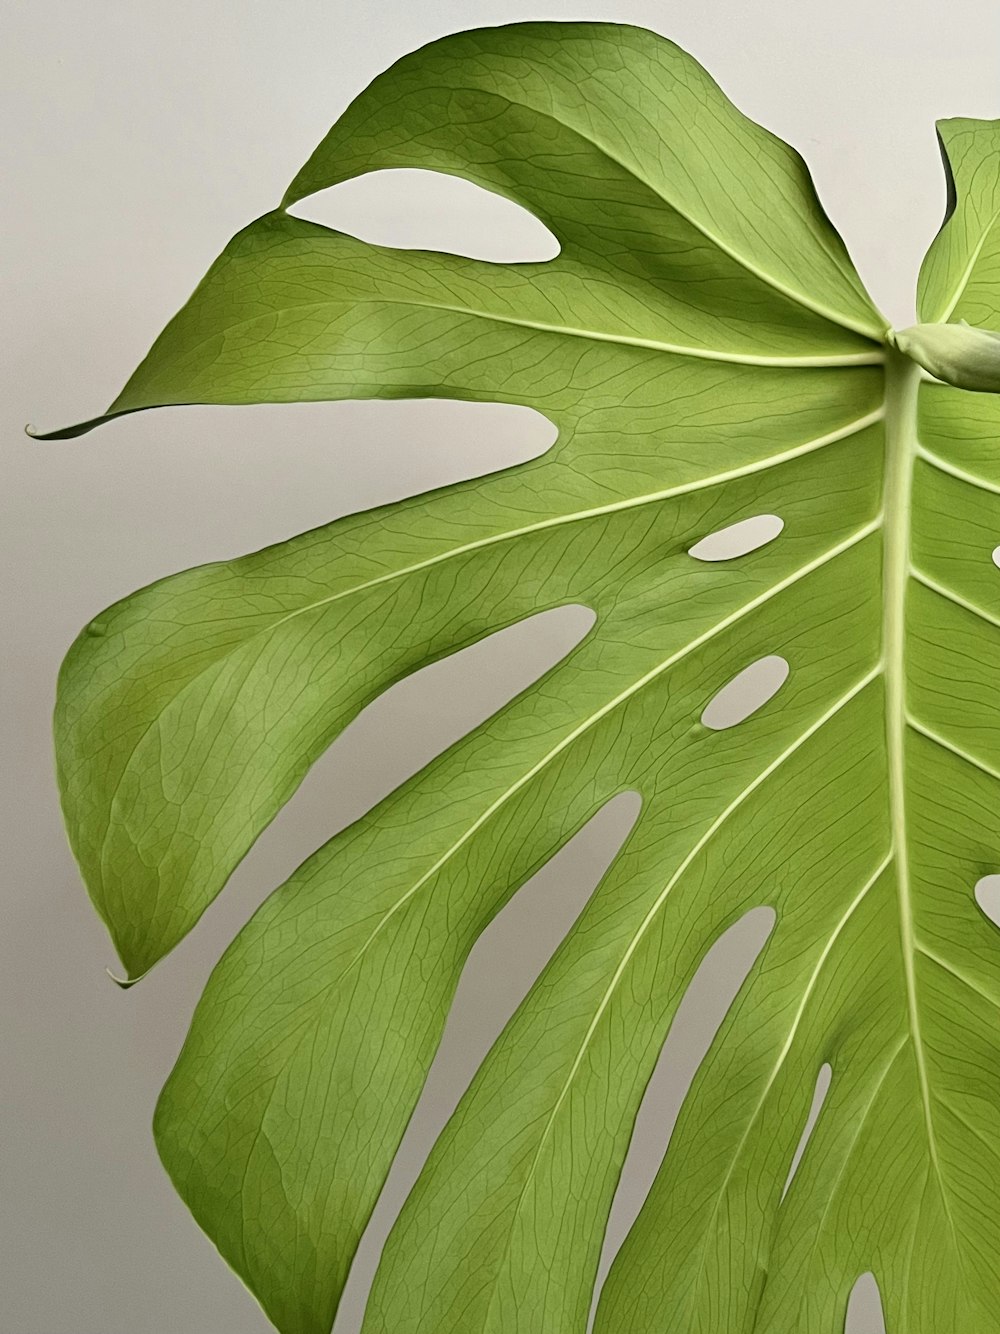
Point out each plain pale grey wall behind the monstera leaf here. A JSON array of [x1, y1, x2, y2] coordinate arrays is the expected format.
[[7, 0, 1000, 1334]]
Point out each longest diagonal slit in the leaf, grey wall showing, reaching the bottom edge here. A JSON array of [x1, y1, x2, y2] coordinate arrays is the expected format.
[[332, 792, 641, 1334]]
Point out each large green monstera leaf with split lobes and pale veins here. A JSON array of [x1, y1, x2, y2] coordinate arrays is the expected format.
[[41, 23, 1000, 1334]]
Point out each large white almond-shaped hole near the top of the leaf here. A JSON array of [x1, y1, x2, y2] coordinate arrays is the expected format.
[[289, 168, 559, 264]]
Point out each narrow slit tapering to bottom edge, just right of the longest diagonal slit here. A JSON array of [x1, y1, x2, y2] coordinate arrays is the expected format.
[[591, 907, 776, 1323]]
